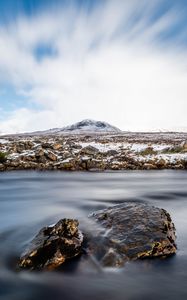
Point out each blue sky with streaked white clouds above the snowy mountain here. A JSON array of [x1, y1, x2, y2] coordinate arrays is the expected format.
[[0, 0, 187, 134]]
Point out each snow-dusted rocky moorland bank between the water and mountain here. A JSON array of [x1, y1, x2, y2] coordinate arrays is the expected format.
[[0, 133, 187, 171]]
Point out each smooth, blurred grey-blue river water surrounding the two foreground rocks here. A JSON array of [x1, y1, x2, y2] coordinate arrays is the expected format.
[[0, 171, 187, 300]]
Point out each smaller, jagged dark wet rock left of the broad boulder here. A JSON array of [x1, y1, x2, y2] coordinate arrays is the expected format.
[[19, 219, 83, 270]]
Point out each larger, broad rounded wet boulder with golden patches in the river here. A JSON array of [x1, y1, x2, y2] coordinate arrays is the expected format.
[[88, 203, 176, 267]]
